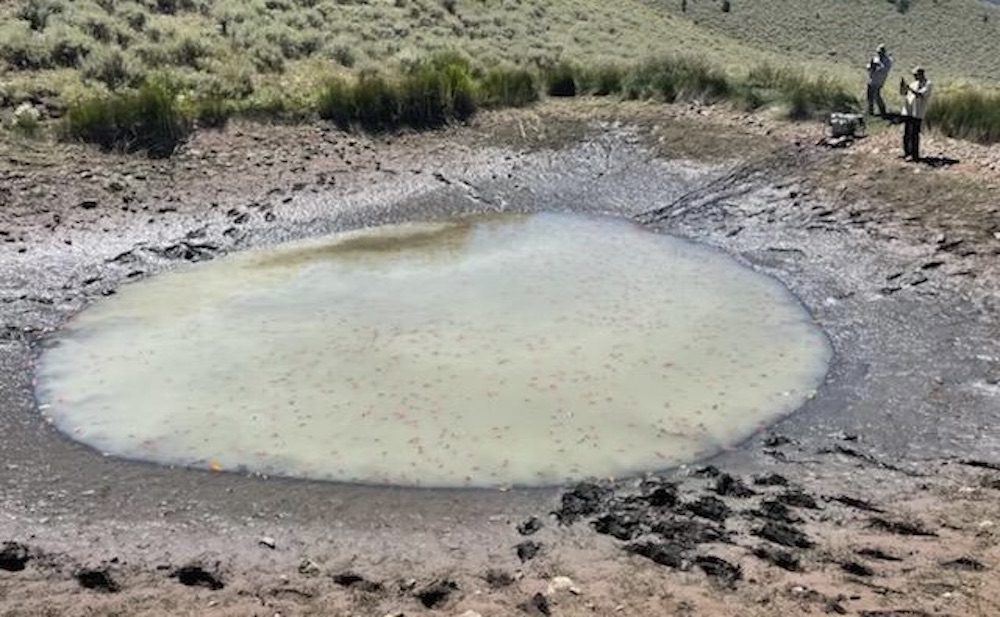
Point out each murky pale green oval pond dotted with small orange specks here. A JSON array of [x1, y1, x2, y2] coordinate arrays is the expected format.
[[38, 214, 831, 486]]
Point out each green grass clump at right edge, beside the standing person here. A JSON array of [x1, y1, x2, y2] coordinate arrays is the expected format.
[[927, 86, 1000, 144]]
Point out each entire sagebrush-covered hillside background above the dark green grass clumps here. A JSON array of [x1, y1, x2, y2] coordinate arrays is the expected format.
[[0, 0, 1000, 108]]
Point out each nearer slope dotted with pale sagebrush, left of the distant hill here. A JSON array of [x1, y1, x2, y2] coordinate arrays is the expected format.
[[0, 0, 796, 106]]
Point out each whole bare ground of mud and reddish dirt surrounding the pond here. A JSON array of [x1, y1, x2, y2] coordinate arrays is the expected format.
[[0, 101, 1000, 617]]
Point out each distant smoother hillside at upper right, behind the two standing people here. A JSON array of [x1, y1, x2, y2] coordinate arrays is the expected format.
[[647, 0, 1000, 82]]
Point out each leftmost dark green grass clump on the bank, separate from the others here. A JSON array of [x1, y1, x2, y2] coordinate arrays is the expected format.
[[62, 79, 191, 157]]
